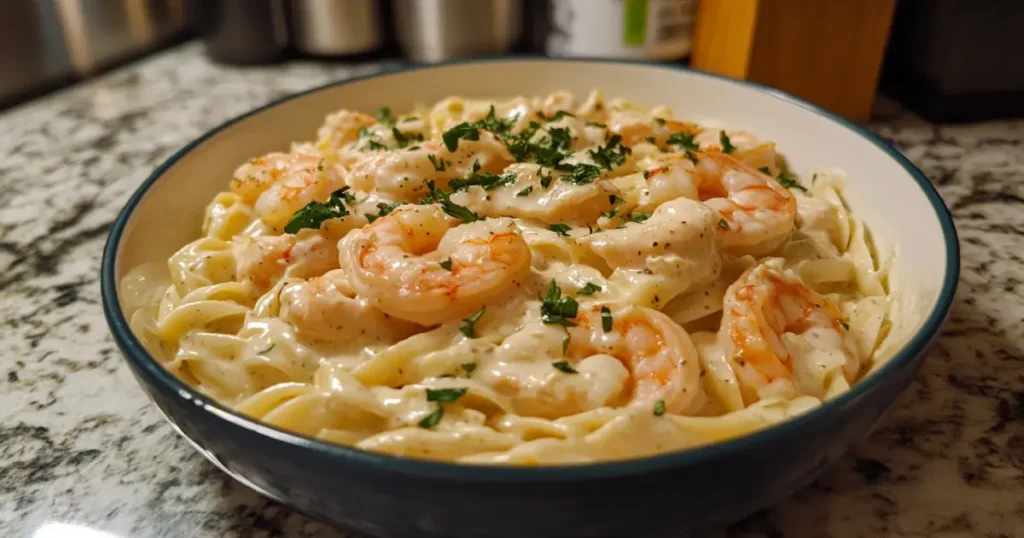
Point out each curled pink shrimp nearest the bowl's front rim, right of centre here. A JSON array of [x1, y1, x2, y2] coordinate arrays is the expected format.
[[566, 305, 702, 414]]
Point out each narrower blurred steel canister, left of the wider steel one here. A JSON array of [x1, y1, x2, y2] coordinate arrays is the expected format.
[[290, 0, 384, 55]]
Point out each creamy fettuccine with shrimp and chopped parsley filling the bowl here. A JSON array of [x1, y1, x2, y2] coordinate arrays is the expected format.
[[121, 91, 890, 465]]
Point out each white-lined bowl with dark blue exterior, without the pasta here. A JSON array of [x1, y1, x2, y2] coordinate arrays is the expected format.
[[101, 58, 959, 537]]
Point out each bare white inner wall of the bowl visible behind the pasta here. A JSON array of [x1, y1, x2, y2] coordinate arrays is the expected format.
[[108, 59, 958, 457]]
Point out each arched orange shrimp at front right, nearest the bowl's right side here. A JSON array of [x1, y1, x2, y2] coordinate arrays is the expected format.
[[719, 258, 860, 403]]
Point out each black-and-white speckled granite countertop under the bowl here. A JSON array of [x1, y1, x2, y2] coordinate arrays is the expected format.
[[0, 43, 1024, 538]]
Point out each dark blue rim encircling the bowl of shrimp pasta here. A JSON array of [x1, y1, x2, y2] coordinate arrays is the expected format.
[[100, 55, 959, 482]]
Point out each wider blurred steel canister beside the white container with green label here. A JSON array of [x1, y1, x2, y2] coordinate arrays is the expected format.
[[392, 0, 522, 61]]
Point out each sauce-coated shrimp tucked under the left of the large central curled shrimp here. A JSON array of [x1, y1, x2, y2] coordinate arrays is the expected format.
[[281, 270, 420, 347]]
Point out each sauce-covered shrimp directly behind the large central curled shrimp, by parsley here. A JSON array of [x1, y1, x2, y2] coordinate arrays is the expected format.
[[348, 130, 513, 202]]
